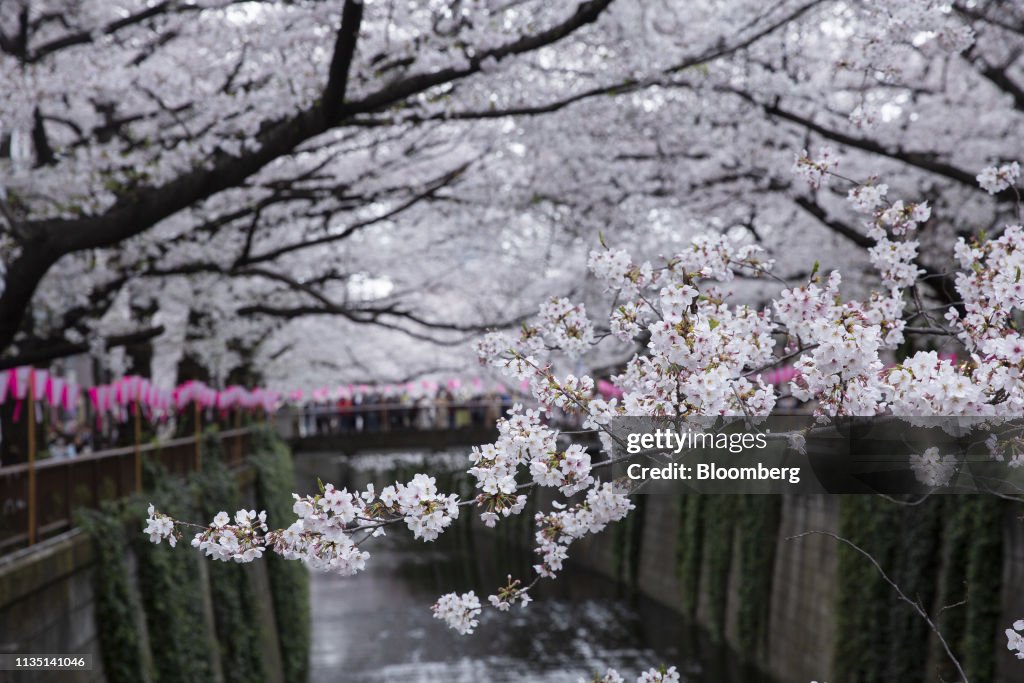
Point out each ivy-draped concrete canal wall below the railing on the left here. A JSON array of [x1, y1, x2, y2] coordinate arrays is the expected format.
[[0, 436, 309, 683]]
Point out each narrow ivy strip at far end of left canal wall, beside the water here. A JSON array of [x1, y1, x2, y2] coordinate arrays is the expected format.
[[250, 429, 311, 683]]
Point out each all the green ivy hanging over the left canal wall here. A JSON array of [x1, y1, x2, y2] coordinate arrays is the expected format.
[[78, 433, 310, 683]]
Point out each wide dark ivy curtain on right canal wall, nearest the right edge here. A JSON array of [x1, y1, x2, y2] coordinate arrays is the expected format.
[[836, 496, 1005, 683]]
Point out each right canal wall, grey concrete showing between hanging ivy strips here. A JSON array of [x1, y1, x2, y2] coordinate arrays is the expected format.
[[571, 496, 1024, 683]]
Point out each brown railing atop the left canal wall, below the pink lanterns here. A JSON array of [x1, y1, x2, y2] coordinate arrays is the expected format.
[[0, 429, 250, 553]]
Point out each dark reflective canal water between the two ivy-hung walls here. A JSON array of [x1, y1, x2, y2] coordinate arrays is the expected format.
[[299, 450, 768, 683]]
